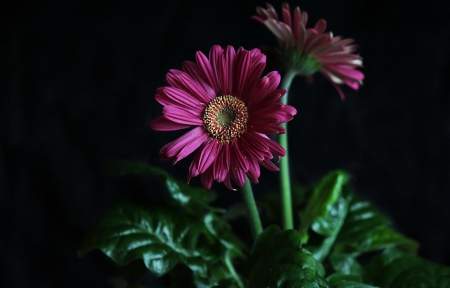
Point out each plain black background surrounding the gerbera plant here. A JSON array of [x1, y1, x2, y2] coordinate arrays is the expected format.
[[0, 0, 450, 287]]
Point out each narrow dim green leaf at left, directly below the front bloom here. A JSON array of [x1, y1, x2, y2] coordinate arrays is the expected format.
[[103, 161, 217, 214]]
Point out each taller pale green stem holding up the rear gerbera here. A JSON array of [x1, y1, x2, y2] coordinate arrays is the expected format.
[[279, 70, 296, 229]]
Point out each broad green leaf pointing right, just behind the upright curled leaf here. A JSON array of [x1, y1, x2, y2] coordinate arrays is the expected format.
[[335, 194, 418, 255]]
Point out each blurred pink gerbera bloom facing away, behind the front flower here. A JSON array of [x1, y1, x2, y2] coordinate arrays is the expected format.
[[253, 3, 364, 99]]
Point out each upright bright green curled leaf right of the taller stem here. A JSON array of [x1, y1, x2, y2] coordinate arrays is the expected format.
[[299, 170, 348, 243]]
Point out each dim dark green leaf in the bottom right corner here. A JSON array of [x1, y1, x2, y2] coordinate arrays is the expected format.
[[367, 250, 450, 288]]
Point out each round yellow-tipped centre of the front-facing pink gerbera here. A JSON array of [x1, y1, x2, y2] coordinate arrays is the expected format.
[[203, 95, 248, 144]]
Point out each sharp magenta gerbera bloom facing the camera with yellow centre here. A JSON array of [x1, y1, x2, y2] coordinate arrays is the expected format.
[[150, 46, 296, 189]]
